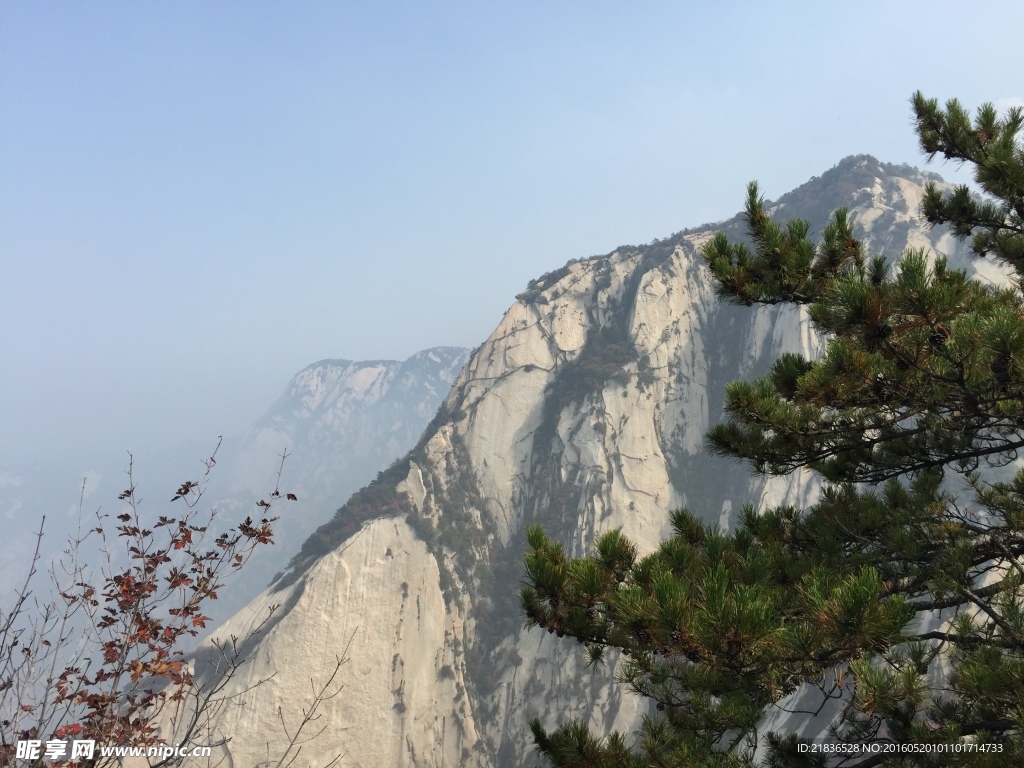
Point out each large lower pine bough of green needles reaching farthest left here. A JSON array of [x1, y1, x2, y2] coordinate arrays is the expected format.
[[520, 510, 913, 765]]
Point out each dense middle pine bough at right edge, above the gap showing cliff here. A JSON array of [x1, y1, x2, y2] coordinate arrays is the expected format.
[[709, 246, 1024, 482]]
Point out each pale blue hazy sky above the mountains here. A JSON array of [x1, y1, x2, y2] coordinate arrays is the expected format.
[[0, 0, 1024, 463]]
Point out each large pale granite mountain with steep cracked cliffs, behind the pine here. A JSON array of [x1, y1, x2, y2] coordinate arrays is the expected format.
[[188, 157, 978, 768]]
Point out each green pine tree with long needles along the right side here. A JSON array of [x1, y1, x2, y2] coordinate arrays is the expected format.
[[520, 93, 1024, 768]]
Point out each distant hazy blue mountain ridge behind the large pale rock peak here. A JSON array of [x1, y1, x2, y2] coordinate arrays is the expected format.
[[0, 347, 469, 618]]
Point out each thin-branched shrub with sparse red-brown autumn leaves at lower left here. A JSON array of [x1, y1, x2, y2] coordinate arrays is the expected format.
[[0, 440, 347, 768]]
